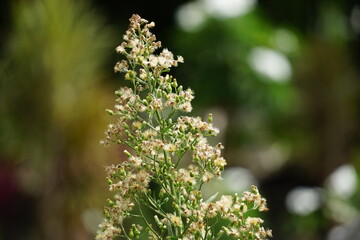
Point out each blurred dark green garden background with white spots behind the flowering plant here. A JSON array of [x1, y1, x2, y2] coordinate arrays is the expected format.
[[0, 0, 360, 240]]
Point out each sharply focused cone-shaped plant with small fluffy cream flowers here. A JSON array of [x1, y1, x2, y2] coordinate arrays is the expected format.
[[96, 15, 271, 240]]
